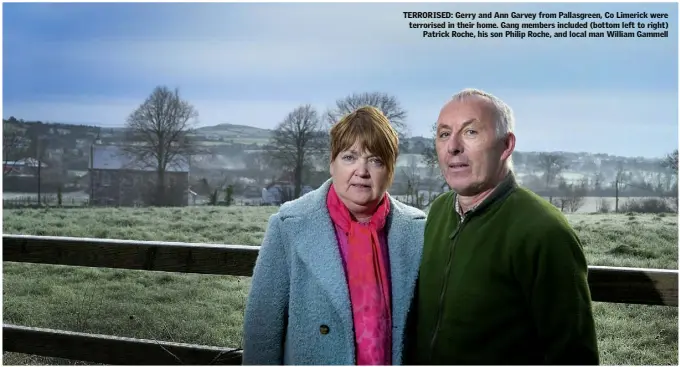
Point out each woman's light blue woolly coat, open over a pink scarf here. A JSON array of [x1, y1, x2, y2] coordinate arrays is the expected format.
[[243, 180, 425, 365]]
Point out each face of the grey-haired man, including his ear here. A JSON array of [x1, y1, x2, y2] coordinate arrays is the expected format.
[[435, 96, 515, 196]]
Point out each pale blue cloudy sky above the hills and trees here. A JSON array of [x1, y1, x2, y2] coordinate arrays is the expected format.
[[3, 3, 678, 157]]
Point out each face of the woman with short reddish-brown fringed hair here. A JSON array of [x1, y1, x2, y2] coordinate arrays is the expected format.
[[330, 143, 388, 214]]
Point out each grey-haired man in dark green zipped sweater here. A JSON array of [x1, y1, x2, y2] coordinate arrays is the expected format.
[[406, 90, 599, 365]]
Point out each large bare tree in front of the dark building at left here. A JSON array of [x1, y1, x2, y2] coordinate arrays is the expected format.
[[124, 86, 198, 205]]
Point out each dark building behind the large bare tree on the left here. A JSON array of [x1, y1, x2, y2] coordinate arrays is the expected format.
[[88, 144, 189, 206]]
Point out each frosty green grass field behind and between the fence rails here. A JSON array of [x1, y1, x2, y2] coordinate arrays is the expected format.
[[3, 207, 678, 365]]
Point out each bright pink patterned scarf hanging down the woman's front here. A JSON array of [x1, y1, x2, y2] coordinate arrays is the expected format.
[[326, 185, 392, 365]]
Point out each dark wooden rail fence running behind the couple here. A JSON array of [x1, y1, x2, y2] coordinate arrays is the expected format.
[[2, 235, 678, 365]]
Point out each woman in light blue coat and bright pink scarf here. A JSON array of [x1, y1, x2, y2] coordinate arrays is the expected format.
[[243, 107, 425, 365]]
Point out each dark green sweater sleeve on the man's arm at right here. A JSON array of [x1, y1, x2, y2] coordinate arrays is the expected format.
[[513, 222, 599, 365]]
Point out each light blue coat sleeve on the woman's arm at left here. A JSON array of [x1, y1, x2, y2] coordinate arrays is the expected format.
[[243, 215, 289, 365]]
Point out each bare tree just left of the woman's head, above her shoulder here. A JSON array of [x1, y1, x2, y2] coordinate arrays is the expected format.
[[269, 105, 327, 197]]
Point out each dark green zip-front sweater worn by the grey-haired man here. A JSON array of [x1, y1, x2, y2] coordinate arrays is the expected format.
[[406, 174, 599, 365]]
